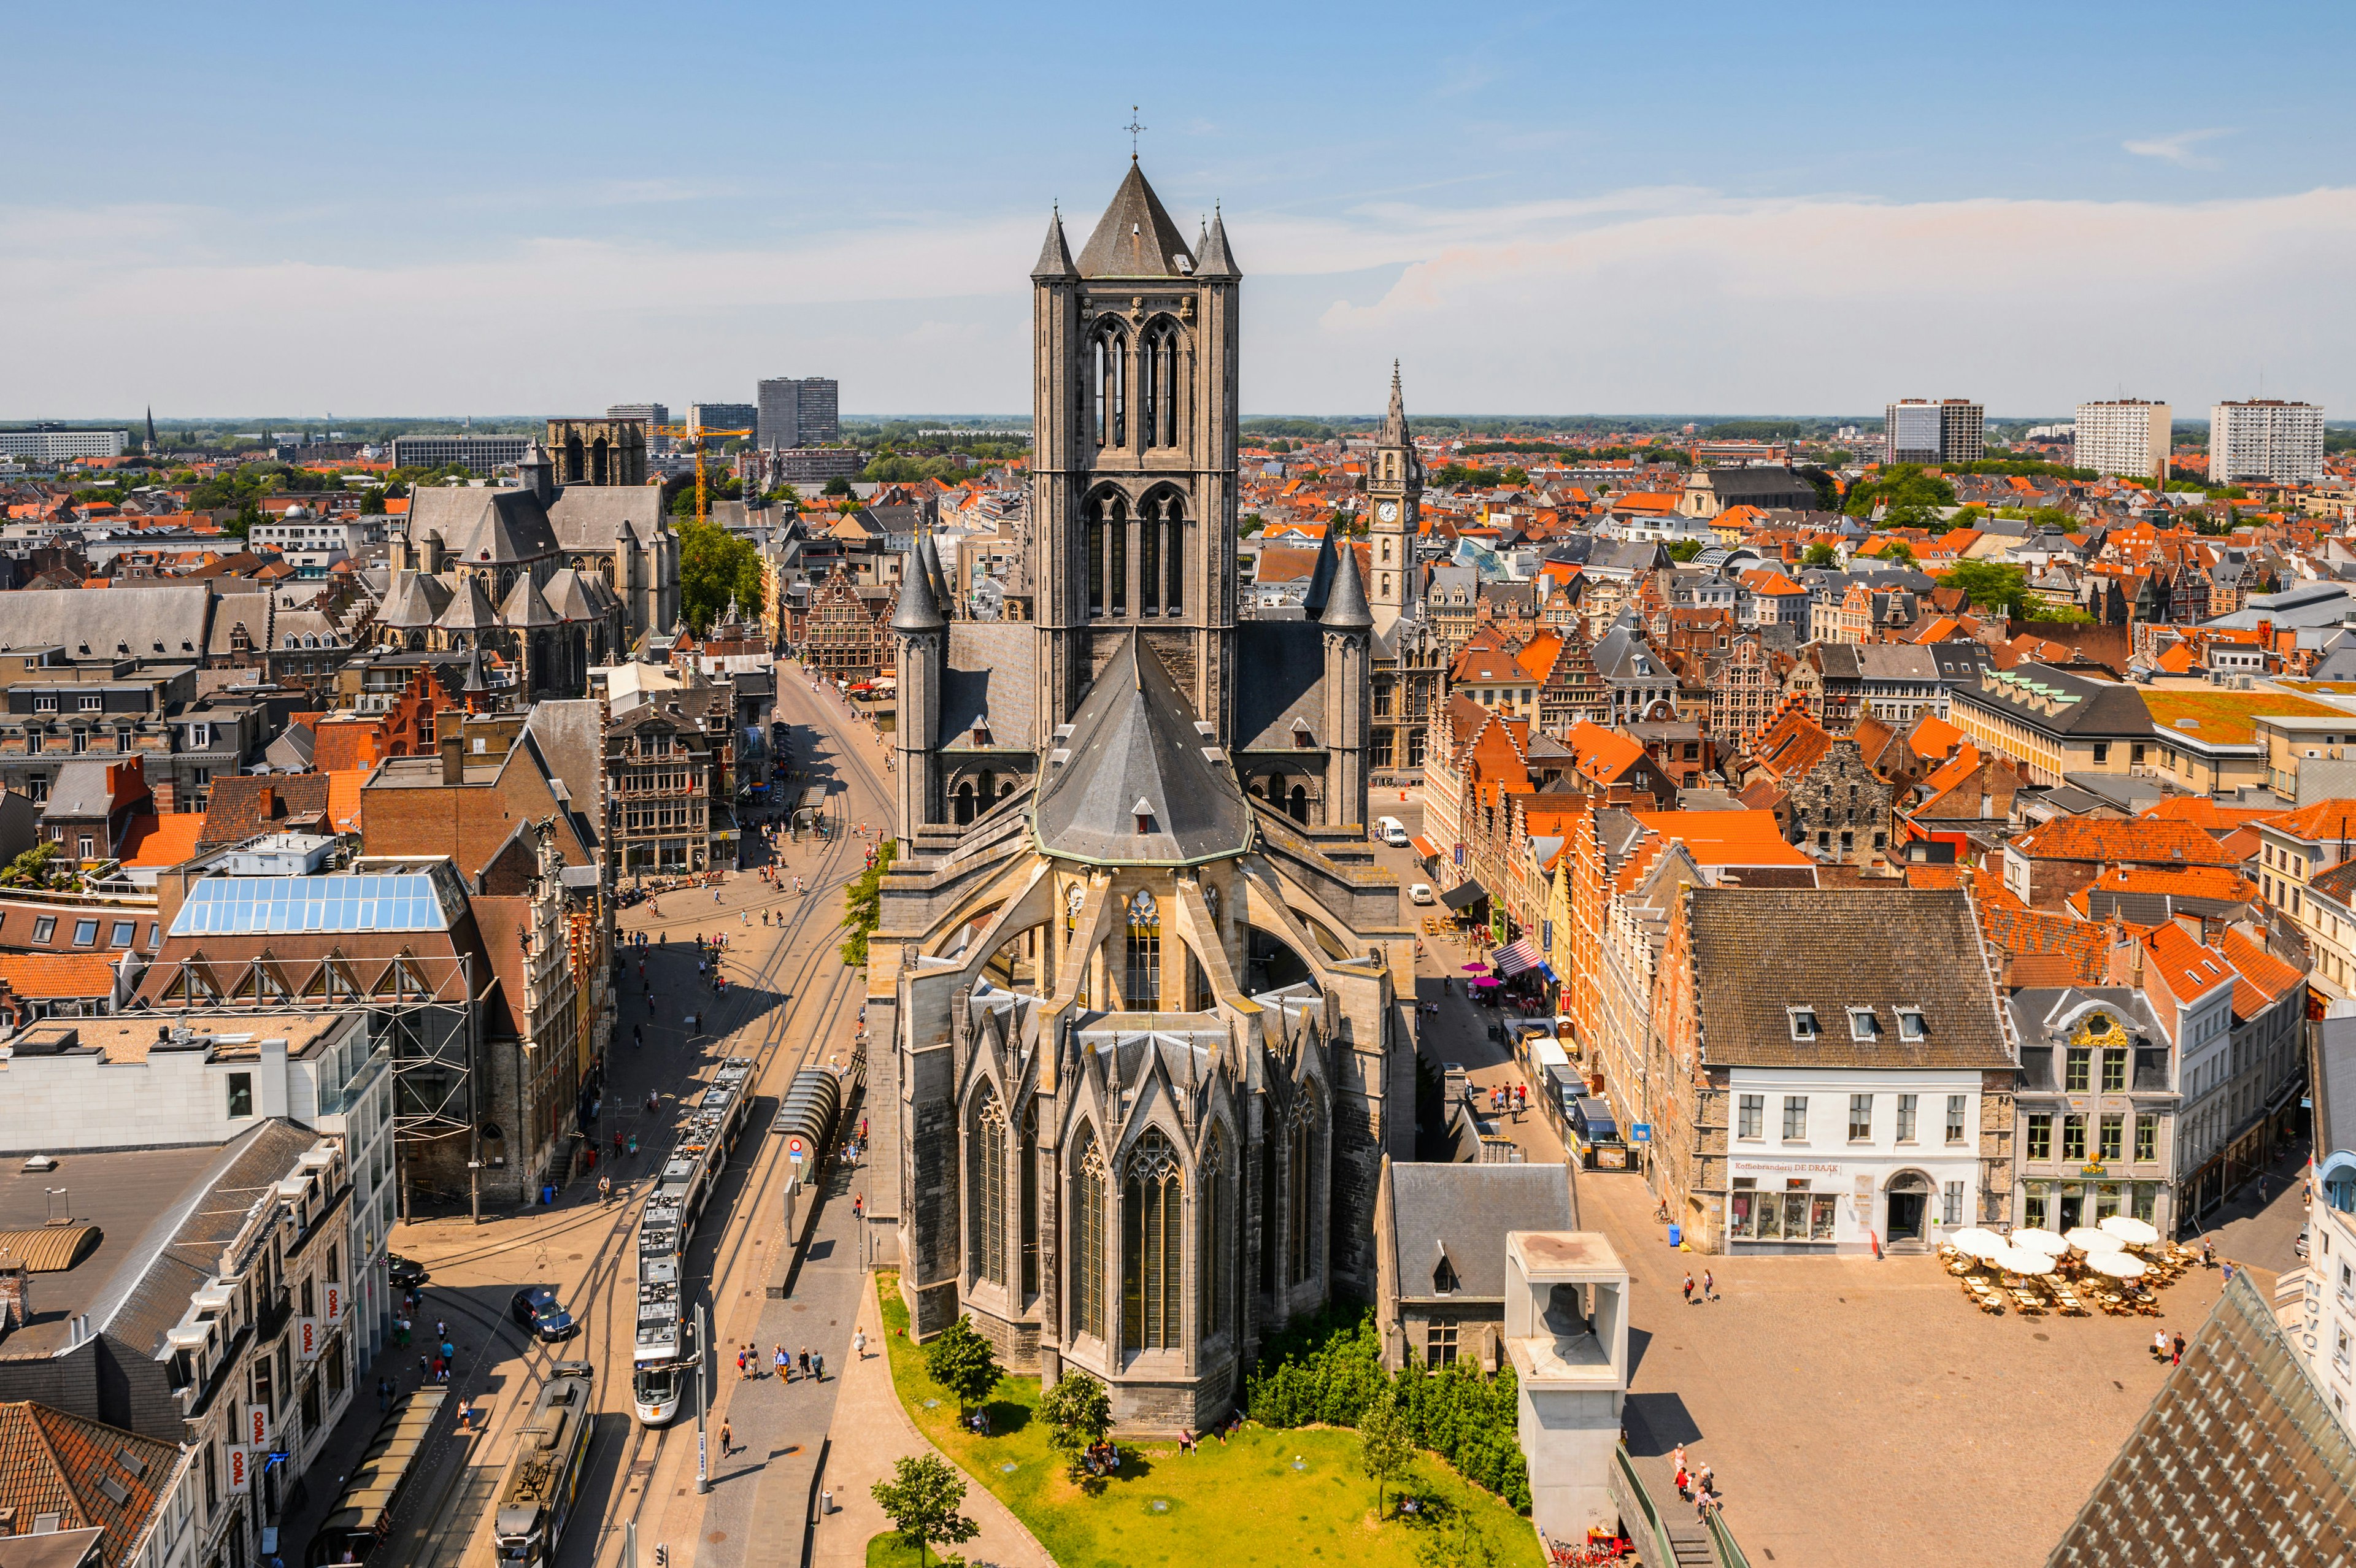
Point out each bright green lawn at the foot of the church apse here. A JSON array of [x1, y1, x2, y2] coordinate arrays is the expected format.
[[867, 1274, 1541, 1568]]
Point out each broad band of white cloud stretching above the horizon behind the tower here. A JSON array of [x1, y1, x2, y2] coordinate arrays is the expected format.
[[0, 188, 2356, 417]]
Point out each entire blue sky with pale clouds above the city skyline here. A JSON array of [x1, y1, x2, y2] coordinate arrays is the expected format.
[[0, 2, 2356, 417]]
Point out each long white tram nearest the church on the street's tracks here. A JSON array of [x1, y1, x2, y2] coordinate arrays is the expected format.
[[631, 1057, 752, 1427]]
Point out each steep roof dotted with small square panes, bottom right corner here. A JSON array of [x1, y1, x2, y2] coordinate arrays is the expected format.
[[2047, 1271, 2356, 1568]]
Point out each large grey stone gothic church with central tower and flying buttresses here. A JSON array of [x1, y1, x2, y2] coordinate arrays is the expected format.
[[867, 160, 1414, 1431]]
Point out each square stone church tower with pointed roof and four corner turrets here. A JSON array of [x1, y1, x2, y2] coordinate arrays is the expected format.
[[1032, 158, 1242, 744]]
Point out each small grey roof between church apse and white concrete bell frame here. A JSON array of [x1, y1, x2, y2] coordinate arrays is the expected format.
[[1385, 1161, 1579, 1302]]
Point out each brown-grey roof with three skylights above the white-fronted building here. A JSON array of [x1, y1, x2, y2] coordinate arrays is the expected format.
[[1687, 888, 2014, 1069]]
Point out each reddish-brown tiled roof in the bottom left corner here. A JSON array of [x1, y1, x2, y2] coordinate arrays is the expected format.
[[0, 1399, 179, 1568]]
